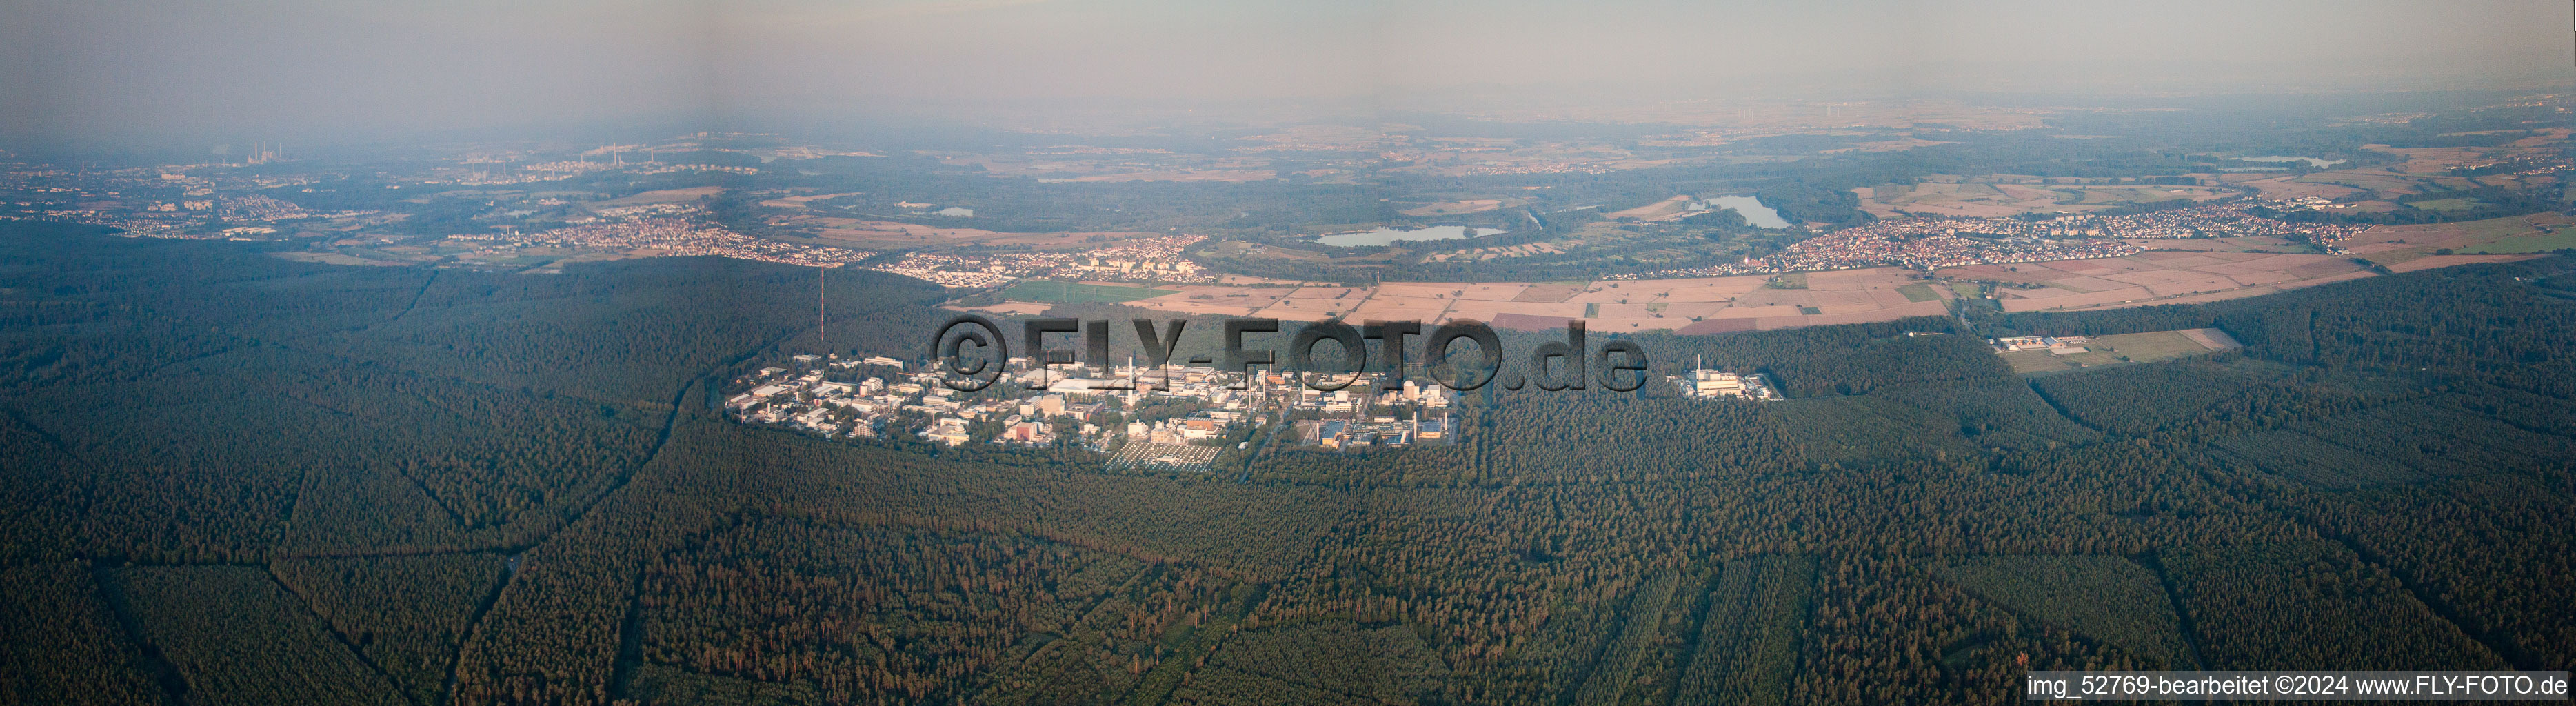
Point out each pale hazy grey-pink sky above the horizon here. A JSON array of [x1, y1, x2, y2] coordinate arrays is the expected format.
[[0, 0, 2576, 139]]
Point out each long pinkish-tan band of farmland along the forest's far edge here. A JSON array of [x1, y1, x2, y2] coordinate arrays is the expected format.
[[1005, 214, 2576, 335]]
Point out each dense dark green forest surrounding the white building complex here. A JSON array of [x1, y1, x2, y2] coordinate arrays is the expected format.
[[0, 219, 2576, 706]]
